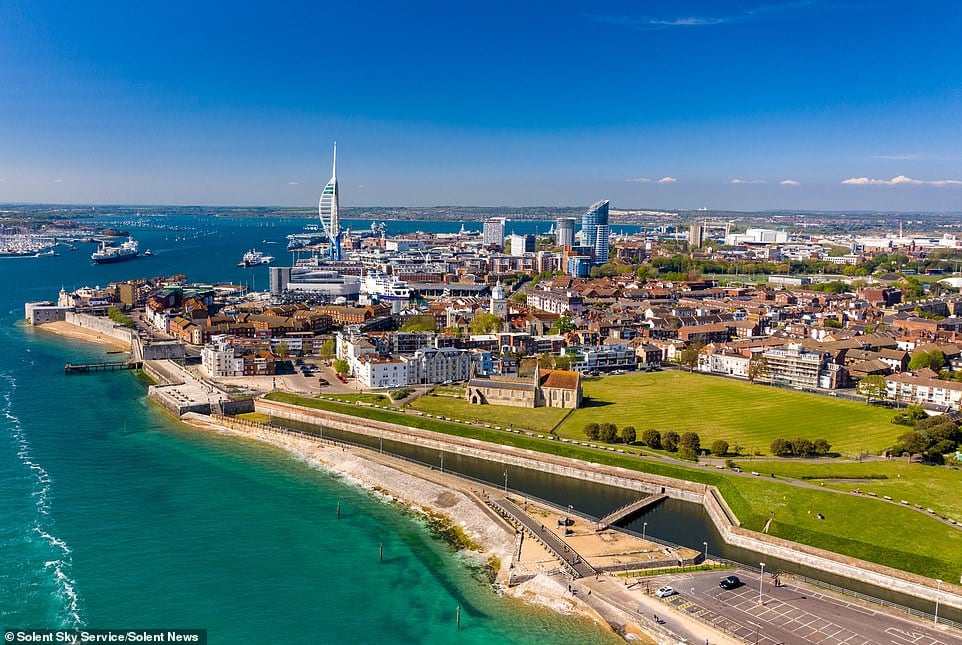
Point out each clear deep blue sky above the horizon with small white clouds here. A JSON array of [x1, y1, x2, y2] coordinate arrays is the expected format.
[[0, 0, 962, 211]]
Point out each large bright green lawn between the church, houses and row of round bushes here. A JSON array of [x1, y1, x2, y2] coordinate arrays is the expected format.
[[558, 370, 904, 455]]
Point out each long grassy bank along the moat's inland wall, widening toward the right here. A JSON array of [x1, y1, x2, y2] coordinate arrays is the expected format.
[[268, 393, 962, 580]]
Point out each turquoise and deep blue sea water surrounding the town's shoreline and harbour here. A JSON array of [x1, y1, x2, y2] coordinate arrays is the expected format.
[[0, 216, 618, 644]]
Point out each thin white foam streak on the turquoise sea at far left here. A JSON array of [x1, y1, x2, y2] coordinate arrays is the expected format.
[[0, 374, 84, 628]]
